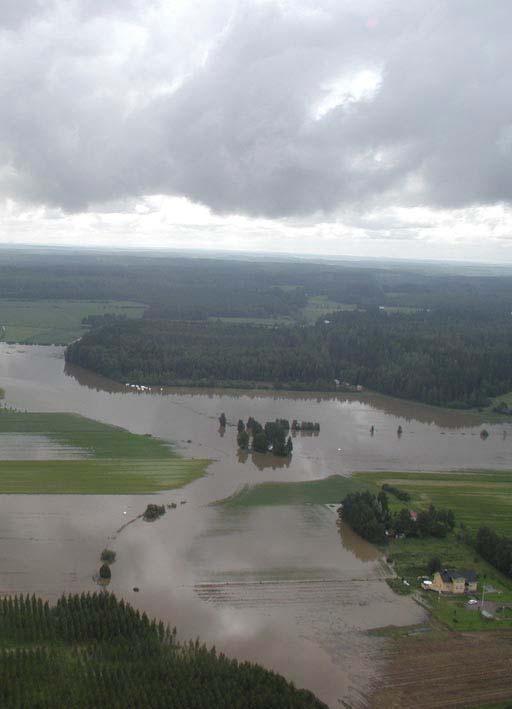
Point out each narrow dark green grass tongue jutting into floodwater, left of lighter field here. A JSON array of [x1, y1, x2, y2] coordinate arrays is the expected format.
[[218, 475, 368, 507]]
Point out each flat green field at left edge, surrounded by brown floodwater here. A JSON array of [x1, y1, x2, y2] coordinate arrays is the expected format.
[[0, 411, 208, 494]]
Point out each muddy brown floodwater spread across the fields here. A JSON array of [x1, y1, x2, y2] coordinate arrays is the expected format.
[[0, 345, 512, 707]]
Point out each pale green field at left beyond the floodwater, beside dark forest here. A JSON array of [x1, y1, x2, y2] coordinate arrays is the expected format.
[[0, 300, 145, 345]]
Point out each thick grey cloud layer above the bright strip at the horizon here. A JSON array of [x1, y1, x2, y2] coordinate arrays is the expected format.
[[0, 0, 512, 217]]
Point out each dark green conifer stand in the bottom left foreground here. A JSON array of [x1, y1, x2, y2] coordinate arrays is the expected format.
[[0, 593, 326, 709]]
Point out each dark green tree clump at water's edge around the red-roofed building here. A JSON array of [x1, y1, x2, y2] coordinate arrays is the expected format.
[[338, 490, 455, 543]]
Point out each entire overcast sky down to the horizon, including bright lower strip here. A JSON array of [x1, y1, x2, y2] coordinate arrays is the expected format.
[[0, 0, 512, 263]]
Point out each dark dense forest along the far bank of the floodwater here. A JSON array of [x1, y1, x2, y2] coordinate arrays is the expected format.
[[66, 309, 512, 408]]
